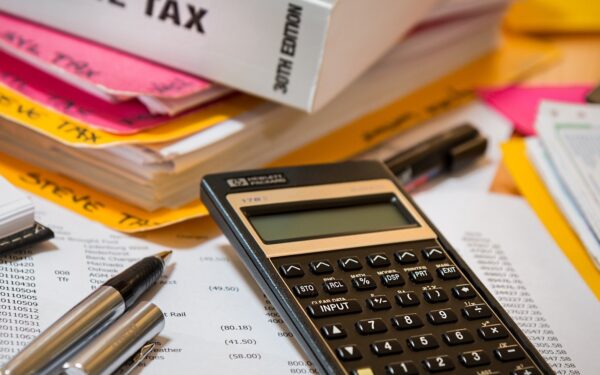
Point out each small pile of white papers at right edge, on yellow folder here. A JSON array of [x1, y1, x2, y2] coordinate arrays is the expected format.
[[527, 102, 600, 268]]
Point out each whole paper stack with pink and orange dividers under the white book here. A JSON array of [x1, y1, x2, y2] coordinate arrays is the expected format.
[[0, 0, 549, 230]]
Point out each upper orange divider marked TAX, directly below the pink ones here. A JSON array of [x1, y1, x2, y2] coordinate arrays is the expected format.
[[0, 84, 262, 147]]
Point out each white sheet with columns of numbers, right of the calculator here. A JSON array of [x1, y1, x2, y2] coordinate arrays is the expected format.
[[417, 192, 600, 375]]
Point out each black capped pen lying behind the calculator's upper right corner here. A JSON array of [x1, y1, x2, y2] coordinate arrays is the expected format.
[[385, 124, 487, 191]]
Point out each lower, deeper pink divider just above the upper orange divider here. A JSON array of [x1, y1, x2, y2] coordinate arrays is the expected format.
[[0, 51, 177, 134]]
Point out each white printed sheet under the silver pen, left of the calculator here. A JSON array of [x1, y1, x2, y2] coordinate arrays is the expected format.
[[0, 199, 314, 375]]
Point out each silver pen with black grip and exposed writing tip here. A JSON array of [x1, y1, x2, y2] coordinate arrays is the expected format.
[[0, 251, 172, 375]]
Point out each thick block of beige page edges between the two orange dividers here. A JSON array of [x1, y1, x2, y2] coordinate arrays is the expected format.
[[0, 11, 501, 211]]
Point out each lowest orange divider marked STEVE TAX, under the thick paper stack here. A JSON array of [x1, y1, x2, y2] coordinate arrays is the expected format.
[[0, 153, 208, 233]]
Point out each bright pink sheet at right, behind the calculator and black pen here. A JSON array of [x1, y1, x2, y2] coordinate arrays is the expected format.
[[478, 85, 592, 135]]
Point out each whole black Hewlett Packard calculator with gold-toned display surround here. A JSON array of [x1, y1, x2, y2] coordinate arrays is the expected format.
[[201, 161, 553, 375]]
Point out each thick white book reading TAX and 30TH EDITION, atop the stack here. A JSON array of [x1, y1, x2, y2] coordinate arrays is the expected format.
[[0, 0, 442, 111]]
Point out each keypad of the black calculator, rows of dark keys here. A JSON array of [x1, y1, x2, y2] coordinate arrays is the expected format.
[[272, 241, 539, 375]]
